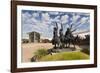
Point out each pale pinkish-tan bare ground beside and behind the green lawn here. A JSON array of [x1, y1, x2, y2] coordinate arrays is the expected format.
[[22, 43, 89, 62]]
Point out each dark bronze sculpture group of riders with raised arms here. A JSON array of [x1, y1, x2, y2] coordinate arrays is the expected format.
[[52, 23, 79, 49]]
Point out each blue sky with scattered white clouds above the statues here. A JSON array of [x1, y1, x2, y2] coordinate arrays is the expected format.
[[22, 10, 90, 38]]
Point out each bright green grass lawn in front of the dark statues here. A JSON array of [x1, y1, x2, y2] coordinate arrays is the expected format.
[[40, 52, 89, 61]]
